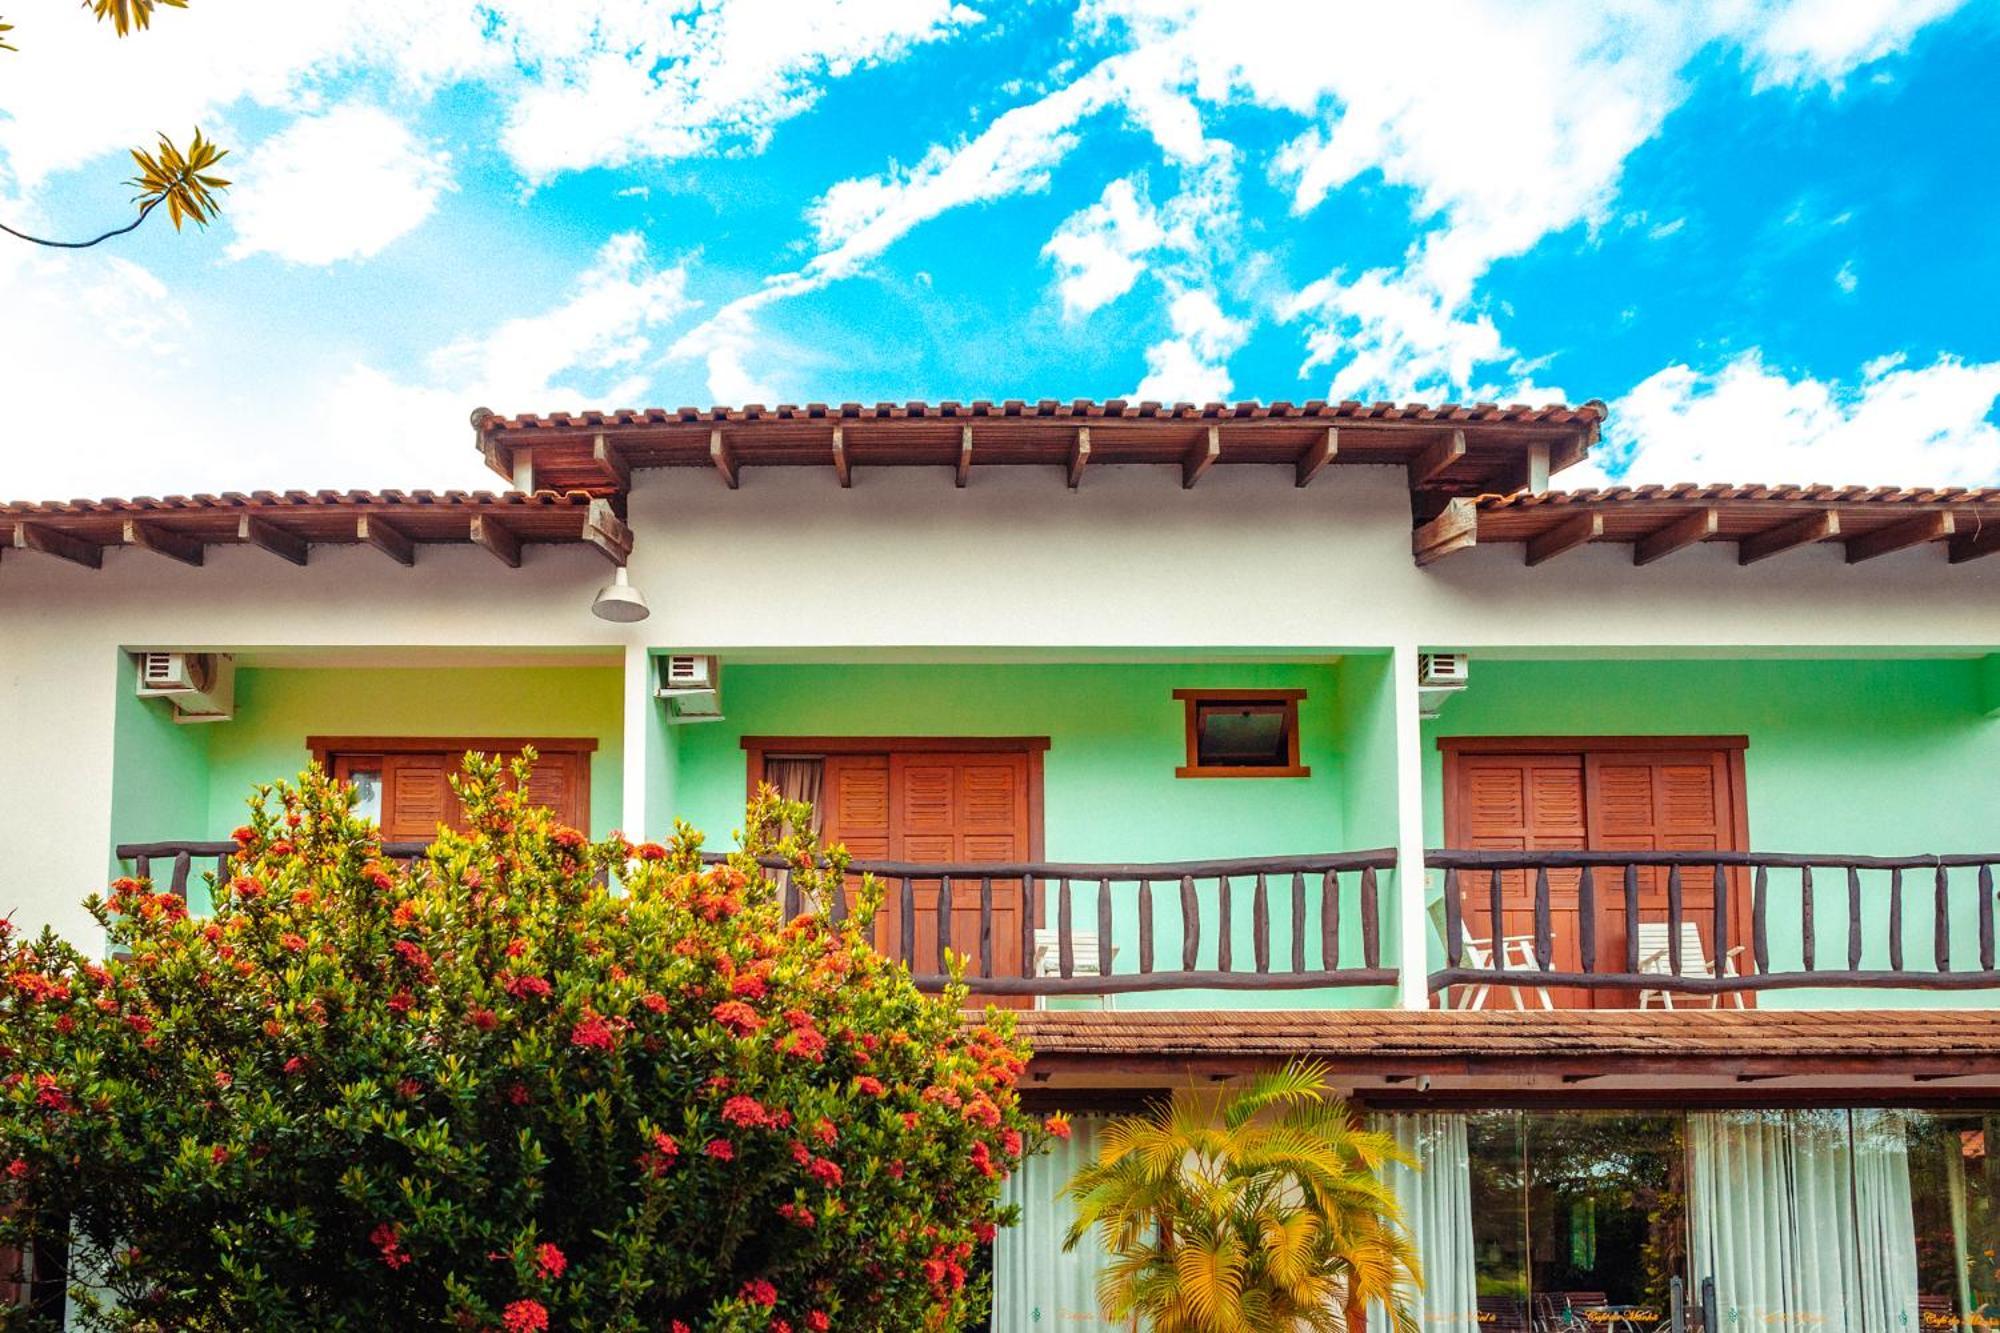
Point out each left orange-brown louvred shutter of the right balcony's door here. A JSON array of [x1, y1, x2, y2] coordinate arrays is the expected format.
[[1446, 755, 1602, 1009]]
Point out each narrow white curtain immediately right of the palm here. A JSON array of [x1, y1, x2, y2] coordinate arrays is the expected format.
[[1368, 1113, 1480, 1333]]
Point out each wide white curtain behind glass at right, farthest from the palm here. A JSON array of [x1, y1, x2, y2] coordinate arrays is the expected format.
[[1688, 1111, 1916, 1333]]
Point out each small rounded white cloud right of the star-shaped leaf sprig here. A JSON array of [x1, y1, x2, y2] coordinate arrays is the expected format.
[[224, 102, 452, 264]]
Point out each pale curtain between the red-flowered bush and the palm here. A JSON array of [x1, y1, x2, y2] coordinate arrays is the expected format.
[[994, 1115, 1128, 1333]]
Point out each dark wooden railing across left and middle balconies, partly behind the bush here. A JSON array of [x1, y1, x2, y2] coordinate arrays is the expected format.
[[116, 843, 1396, 997]]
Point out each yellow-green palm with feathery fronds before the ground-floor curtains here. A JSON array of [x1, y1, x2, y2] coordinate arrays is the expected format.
[[1064, 1063, 1422, 1333]]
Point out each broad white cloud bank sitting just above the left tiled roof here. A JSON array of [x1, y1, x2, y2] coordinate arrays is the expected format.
[[0, 234, 690, 498]]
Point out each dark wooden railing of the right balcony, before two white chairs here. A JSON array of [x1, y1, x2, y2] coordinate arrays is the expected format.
[[1424, 851, 2000, 995]]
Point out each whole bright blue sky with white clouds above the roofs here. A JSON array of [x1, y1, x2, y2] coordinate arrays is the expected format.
[[0, 0, 2000, 498]]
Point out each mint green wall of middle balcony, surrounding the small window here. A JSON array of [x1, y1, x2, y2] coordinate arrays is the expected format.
[[672, 662, 1386, 1007]]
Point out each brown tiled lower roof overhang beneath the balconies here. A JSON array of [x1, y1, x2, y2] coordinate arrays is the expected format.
[[1018, 1009, 2000, 1107]]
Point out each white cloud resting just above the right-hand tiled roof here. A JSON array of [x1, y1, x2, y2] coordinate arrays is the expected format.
[[1562, 350, 2000, 488]]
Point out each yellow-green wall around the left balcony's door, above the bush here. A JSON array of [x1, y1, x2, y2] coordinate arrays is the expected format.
[[206, 667, 624, 835]]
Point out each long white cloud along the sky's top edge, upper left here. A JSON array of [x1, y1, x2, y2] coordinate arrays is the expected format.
[[0, 0, 980, 197]]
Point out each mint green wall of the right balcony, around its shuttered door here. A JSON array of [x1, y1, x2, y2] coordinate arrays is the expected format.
[[1424, 656, 2000, 1007]]
